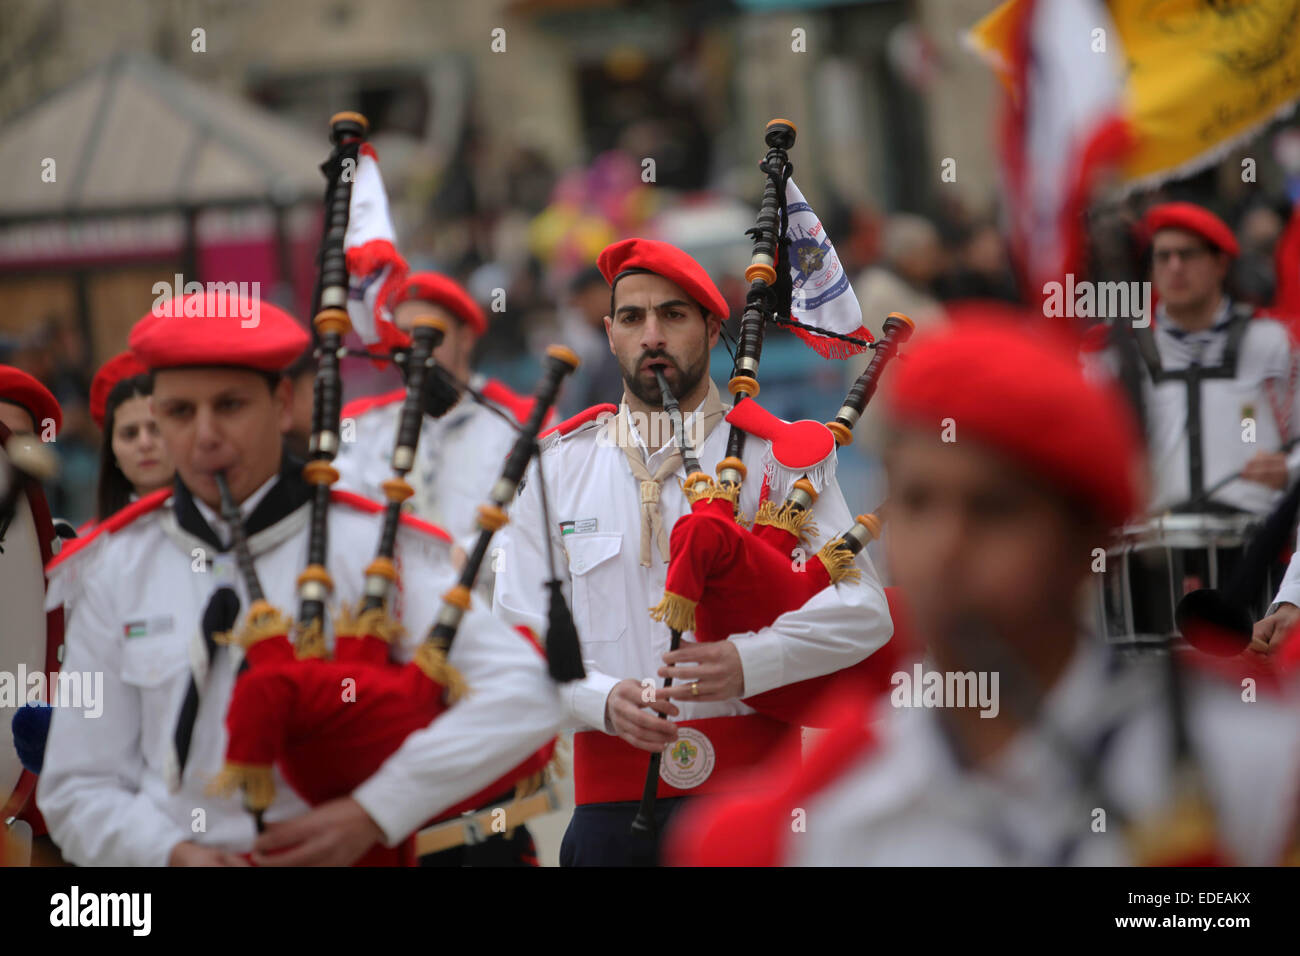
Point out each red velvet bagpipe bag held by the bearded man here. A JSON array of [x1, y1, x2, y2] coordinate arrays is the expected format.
[[655, 497, 904, 727]]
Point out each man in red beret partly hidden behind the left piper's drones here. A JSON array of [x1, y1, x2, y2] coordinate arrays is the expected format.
[[334, 272, 543, 548]]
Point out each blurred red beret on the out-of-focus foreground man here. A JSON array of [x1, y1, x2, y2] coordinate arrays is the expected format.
[[887, 306, 1143, 525]]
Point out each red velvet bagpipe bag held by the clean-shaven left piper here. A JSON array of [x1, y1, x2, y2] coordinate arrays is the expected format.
[[217, 627, 555, 866]]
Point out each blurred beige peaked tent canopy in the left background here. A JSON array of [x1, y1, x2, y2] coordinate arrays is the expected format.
[[0, 55, 324, 222]]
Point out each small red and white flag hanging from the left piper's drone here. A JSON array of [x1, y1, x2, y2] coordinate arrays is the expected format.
[[343, 143, 410, 352]]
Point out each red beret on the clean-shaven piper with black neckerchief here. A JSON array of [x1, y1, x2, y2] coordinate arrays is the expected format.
[[127, 293, 312, 372]]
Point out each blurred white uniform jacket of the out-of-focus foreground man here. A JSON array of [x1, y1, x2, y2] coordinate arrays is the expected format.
[[780, 646, 1300, 866]]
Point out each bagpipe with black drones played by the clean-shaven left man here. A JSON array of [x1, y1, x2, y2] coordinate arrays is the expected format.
[[204, 113, 581, 865]]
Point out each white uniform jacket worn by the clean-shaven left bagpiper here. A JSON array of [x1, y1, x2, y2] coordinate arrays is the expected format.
[[38, 468, 563, 865]]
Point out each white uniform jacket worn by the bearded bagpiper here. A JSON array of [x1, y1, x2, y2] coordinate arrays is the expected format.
[[493, 400, 893, 734]]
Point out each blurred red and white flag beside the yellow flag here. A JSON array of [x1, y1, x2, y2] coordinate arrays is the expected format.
[[971, 0, 1134, 303]]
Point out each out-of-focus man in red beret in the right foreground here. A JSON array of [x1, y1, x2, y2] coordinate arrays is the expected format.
[[668, 307, 1300, 866]]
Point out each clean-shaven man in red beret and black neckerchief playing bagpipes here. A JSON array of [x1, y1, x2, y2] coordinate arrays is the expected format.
[[39, 297, 562, 865]]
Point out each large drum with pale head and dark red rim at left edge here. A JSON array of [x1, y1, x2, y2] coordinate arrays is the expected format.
[[0, 424, 64, 826]]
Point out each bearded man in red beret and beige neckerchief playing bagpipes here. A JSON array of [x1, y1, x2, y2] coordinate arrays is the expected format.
[[494, 239, 892, 865]]
